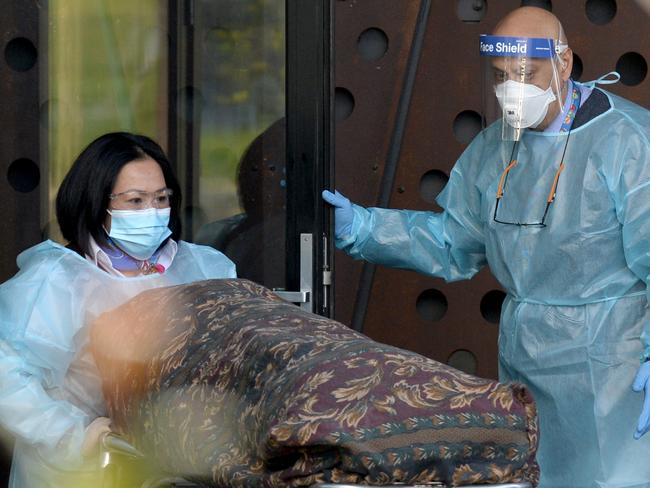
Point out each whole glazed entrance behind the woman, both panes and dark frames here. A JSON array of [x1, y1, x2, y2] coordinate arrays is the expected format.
[[41, 0, 331, 314]]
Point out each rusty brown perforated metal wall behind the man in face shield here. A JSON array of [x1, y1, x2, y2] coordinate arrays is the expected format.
[[336, 0, 650, 378]]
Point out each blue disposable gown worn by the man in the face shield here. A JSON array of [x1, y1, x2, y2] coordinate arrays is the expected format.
[[337, 87, 650, 488]]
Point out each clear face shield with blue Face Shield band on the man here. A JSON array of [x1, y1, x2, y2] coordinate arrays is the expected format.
[[480, 35, 567, 141]]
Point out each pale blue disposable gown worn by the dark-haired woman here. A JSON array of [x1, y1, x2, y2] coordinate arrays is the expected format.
[[0, 241, 235, 488]]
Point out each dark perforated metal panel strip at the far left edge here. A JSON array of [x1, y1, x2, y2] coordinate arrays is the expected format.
[[0, 0, 41, 282]]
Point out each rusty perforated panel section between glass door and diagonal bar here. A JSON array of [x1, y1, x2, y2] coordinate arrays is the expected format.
[[335, 0, 419, 324]]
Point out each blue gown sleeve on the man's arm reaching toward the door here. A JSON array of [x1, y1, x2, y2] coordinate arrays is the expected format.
[[336, 154, 486, 281]]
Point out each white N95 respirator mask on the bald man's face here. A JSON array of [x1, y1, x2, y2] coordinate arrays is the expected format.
[[494, 80, 556, 129]]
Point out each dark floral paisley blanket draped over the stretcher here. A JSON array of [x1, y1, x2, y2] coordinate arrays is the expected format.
[[92, 279, 538, 487]]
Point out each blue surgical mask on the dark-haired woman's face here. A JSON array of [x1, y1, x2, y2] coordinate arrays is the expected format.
[[107, 208, 172, 260]]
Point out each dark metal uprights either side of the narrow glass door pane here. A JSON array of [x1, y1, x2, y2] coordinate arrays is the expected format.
[[167, 0, 334, 316]]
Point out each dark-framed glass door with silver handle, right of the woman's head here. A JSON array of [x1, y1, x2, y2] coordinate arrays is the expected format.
[[169, 0, 332, 314]]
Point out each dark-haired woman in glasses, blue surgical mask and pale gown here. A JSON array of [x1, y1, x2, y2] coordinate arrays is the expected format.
[[0, 133, 236, 487]]
